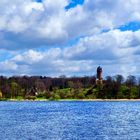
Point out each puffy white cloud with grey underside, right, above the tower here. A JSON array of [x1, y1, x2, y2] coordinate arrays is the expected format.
[[64, 30, 140, 60]]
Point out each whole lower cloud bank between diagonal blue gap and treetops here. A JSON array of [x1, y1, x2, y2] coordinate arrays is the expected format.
[[0, 30, 140, 76]]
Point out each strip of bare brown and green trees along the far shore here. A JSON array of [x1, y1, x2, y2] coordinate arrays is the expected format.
[[0, 75, 140, 100]]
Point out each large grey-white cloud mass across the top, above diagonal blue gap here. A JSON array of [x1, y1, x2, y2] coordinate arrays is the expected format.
[[0, 0, 140, 49]]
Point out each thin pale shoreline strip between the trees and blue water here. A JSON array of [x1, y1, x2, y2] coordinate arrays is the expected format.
[[0, 99, 140, 102]]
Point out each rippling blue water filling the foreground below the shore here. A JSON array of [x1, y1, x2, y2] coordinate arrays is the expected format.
[[0, 101, 140, 140]]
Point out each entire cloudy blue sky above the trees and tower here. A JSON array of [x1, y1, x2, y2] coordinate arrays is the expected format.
[[0, 0, 140, 77]]
